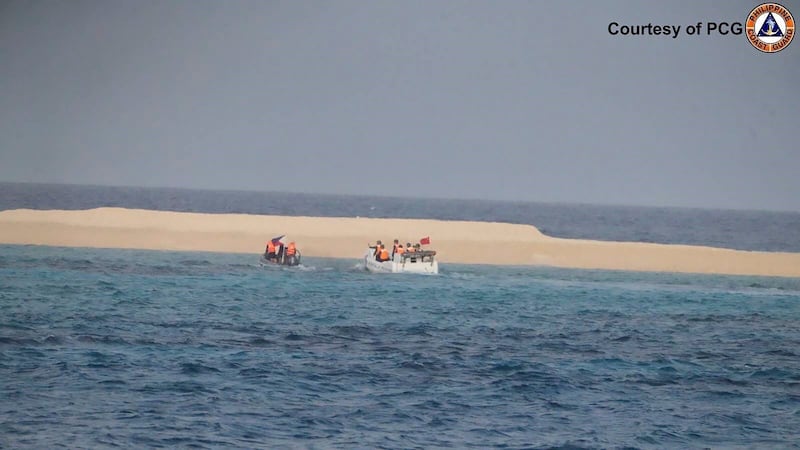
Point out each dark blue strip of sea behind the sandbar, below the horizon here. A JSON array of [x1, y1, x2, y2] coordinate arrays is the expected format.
[[0, 183, 800, 252]]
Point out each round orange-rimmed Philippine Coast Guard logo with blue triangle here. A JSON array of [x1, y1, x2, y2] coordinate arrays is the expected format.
[[745, 3, 794, 53]]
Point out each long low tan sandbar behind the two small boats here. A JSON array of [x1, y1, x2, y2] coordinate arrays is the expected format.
[[0, 208, 800, 277]]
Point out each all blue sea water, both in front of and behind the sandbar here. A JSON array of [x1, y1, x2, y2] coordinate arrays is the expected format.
[[0, 183, 800, 449]]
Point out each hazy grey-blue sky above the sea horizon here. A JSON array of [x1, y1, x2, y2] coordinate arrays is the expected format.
[[0, 0, 800, 211]]
